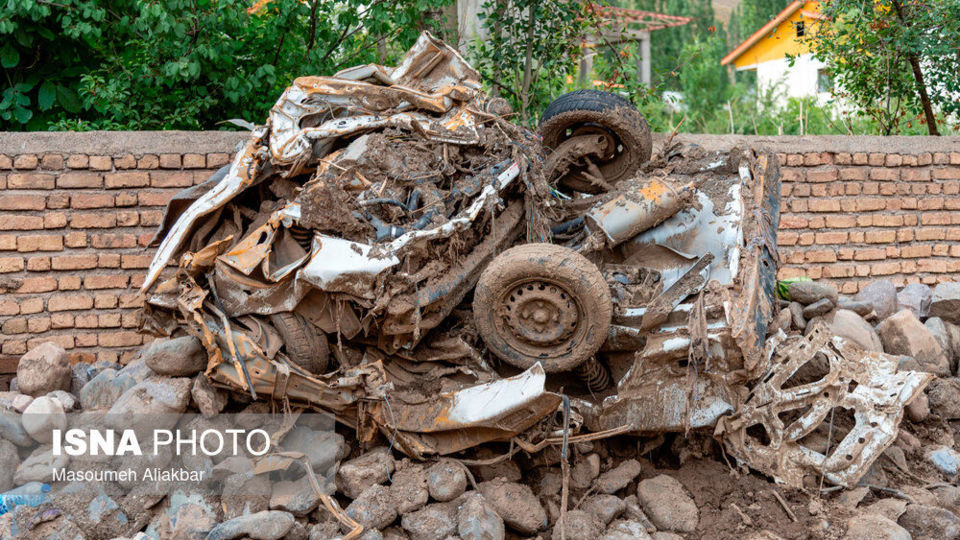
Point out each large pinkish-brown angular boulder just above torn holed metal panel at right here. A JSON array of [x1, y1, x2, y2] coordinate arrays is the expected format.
[[877, 309, 950, 376]]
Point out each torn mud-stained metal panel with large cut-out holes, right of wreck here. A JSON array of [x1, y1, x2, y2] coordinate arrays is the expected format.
[[714, 323, 933, 488]]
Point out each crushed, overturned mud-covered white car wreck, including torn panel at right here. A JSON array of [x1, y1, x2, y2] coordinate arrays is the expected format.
[[142, 34, 929, 486]]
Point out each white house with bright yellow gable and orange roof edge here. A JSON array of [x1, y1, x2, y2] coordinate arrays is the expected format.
[[720, 0, 832, 105]]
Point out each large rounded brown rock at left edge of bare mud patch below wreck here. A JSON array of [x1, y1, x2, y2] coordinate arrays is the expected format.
[[637, 474, 700, 533]]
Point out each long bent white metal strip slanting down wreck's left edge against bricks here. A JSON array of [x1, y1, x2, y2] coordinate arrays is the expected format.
[[140, 135, 265, 293]]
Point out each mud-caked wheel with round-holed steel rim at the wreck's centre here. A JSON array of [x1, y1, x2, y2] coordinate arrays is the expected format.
[[473, 244, 613, 373]]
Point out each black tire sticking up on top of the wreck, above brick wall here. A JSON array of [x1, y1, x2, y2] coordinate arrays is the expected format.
[[540, 90, 653, 193]]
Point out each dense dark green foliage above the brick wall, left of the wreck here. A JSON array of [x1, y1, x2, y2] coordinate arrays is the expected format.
[[0, 0, 451, 130]]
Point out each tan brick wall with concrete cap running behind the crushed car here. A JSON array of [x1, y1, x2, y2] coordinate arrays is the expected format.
[[0, 132, 960, 367]]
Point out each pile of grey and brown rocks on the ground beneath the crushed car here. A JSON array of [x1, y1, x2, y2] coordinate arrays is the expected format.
[[0, 276, 960, 540]]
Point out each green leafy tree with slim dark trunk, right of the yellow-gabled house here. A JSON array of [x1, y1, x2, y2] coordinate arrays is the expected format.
[[807, 0, 960, 135]]
